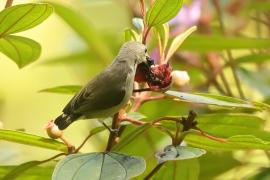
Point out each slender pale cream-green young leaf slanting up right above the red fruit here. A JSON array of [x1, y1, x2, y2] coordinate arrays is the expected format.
[[166, 26, 197, 61]]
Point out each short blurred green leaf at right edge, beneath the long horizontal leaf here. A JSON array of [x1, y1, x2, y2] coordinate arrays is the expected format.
[[234, 53, 270, 64]]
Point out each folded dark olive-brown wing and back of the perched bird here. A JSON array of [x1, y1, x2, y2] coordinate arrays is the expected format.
[[63, 62, 130, 115]]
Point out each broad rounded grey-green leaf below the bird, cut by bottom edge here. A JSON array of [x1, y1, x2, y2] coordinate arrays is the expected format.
[[52, 152, 146, 180]]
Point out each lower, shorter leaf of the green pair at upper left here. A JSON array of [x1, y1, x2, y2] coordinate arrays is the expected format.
[[0, 35, 41, 68]]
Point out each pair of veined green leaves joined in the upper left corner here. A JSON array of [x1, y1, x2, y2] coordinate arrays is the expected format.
[[0, 3, 53, 68]]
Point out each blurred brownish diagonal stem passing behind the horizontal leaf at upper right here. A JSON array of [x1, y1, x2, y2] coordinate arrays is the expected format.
[[212, 0, 245, 99]]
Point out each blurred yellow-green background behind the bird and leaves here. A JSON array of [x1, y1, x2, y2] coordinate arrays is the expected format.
[[0, 0, 270, 180]]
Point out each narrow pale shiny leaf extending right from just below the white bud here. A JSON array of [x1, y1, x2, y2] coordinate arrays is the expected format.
[[165, 91, 262, 109]]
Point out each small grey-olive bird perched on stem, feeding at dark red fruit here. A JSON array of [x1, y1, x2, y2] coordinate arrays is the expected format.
[[54, 41, 150, 130]]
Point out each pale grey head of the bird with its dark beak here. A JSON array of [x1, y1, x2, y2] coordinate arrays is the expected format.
[[118, 41, 153, 66]]
